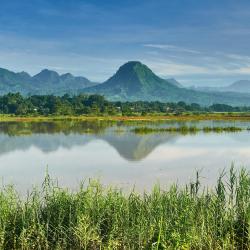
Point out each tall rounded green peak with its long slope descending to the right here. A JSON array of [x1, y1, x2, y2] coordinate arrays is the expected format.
[[82, 61, 250, 105]]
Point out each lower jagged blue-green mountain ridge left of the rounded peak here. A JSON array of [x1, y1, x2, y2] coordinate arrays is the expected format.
[[0, 68, 97, 95]]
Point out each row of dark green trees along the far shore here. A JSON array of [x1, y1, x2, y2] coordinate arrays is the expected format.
[[0, 93, 250, 115]]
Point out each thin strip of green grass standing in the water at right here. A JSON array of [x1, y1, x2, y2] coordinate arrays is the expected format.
[[131, 126, 245, 134]]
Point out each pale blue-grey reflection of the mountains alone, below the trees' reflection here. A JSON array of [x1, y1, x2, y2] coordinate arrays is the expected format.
[[0, 132, 178, 161]]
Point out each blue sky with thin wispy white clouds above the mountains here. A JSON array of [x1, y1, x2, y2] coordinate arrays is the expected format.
[[0, 0, 250, 86]]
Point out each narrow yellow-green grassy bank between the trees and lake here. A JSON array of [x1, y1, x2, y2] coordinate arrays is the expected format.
[[0, 112, 250, 122]]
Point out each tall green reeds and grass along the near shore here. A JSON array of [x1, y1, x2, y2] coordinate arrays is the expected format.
[[0, 168, 250, 249]]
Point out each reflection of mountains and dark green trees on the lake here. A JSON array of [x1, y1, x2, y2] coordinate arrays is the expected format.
[[0, 122, 182, 161]]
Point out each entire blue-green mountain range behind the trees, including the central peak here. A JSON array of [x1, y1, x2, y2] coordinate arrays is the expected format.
[[0, 61, 250, 105]]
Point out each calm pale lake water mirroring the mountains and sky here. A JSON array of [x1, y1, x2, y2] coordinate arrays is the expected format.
[[0, 121, 250, 191]]
